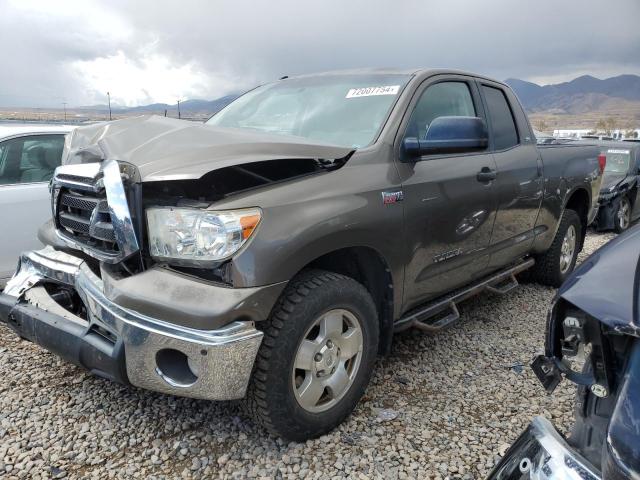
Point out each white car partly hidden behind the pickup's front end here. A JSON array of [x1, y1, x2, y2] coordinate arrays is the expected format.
[[0, 124, 73, 289]]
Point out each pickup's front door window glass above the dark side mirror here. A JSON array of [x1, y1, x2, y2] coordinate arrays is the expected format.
[[405, 82, 476, 139]]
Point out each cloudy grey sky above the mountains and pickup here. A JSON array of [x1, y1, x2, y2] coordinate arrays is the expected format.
[[0, 0, 640, 107]]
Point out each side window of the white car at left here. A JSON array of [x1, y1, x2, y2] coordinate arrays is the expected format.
[[0, 135, 64, 185]]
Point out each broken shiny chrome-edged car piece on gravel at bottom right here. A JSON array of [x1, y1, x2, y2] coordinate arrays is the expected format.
[[488, 417, 601, 480]]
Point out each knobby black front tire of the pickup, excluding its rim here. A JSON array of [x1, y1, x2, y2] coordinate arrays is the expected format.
[[245, 270, 379, 441]]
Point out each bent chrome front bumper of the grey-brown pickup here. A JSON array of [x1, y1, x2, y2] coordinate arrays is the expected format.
[[0, 247, 263, 400]]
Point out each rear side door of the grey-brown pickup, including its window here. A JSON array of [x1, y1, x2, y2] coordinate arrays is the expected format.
[[478, 81, 544, 269]]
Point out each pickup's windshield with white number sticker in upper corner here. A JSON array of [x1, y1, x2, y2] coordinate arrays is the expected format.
[[207, 74, 409, 148]]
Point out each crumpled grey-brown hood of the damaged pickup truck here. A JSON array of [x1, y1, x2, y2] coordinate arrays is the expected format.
[[63, 116, 353, 182]]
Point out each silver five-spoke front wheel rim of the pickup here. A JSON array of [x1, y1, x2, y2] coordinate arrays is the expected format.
[[291, 309, 363, 413]]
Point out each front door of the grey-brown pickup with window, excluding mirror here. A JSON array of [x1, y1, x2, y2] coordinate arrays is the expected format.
[[396, 75, 497, 309]]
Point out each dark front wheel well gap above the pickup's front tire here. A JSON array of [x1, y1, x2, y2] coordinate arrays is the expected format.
[[304, 247, 393, 354]]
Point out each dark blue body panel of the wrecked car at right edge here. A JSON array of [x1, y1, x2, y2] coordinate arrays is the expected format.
[[558, 225, 640, 337]]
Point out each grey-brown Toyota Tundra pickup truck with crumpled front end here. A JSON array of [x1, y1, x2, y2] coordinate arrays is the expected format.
[[0, 70, 605, 440]]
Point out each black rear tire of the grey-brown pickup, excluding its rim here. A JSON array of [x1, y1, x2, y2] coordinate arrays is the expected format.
[[531, 209, 582, 288]]
